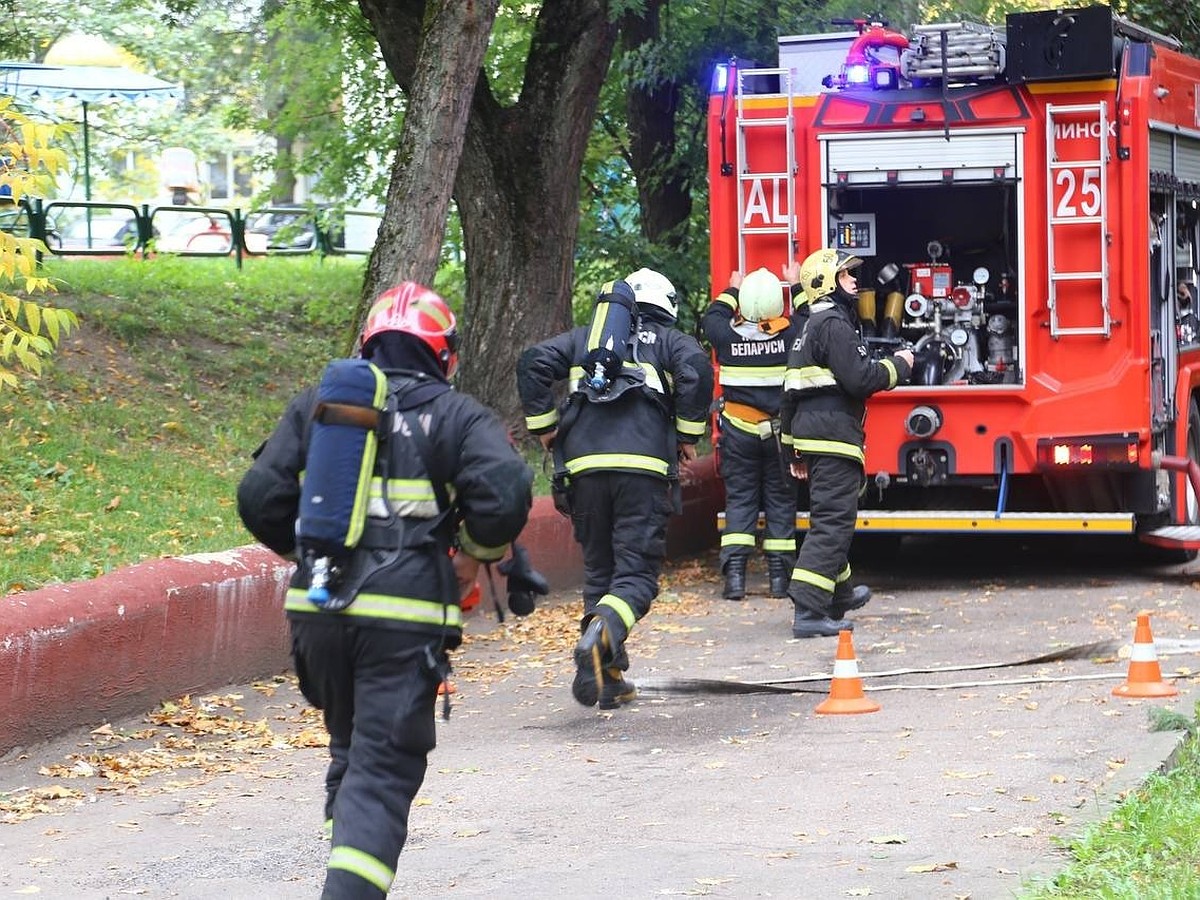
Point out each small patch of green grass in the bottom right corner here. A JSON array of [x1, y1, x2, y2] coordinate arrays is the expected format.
[[1021, 704, 1200, 900]]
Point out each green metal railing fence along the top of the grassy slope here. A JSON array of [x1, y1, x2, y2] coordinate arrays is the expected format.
[[0, 197, 383, 269]]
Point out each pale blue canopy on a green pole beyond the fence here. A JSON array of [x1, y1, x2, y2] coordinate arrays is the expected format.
[[0, 62, 184, 200]]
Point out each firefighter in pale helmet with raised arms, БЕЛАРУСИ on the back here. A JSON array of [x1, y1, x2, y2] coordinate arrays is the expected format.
[[701, 262, 808, 600]]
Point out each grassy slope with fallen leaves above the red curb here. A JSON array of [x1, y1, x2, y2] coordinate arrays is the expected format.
[[0, 257, 364, 594]]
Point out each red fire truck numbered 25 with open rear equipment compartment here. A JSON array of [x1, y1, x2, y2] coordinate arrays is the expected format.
[[708, 6, 1200, 557]]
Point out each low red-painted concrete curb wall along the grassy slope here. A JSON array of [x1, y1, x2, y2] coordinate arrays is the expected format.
[[0, 456, 725, 754]]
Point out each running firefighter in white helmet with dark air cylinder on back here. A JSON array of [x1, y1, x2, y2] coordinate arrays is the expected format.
[[517, 269, 713, 709]]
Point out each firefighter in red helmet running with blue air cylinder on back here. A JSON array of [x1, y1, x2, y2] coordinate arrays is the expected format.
[[238, 282, 533, 899]]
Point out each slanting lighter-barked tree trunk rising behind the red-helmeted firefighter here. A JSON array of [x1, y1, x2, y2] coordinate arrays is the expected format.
[[355, 0, 498, 331]]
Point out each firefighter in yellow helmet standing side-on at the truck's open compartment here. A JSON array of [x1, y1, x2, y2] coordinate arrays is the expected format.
[[781, 250, 912, 637]]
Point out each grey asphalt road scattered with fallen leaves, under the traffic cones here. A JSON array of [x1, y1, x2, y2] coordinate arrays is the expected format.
[[0, 539, 1200, 900]]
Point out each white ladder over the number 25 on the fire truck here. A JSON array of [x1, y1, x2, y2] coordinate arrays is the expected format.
[[1046, 102, 1112, 338]]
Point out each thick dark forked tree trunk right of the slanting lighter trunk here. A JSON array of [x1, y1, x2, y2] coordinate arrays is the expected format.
[[455, 0, 617, 433]]
